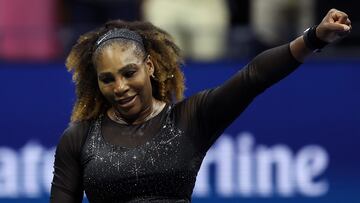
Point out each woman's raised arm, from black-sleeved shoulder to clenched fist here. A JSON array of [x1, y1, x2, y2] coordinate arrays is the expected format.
[[193, 9, 351, 150]]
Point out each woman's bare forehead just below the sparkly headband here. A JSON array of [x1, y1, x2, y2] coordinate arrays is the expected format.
[[95, 43, 141, 72]]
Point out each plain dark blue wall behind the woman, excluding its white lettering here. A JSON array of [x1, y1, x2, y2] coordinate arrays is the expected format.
[[0, 59, 360, 203]]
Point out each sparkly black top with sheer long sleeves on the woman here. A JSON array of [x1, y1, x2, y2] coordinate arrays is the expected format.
[[50, 44, 300, 203]]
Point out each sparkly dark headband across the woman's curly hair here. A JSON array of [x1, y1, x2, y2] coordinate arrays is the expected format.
[[95, 28, 144, 49]]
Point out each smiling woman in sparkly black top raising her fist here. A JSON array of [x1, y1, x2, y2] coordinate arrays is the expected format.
[[51, 9, 351, 202]]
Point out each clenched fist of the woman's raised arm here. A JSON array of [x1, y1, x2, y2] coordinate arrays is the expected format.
[[316, 9, 351, 43]]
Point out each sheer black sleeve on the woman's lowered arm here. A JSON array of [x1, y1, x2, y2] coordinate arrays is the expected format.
[[50, 121, 88, 203]]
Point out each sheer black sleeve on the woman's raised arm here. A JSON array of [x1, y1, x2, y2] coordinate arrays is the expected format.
[[190, 44, 301, 151]]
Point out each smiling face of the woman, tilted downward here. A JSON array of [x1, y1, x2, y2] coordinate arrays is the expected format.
[[95, 44, 154, 119]]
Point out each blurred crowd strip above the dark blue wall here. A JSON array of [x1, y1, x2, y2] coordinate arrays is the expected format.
[[0, 0, 360, 61]]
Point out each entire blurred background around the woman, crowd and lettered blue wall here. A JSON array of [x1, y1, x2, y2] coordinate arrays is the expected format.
[[0, 0, 360, 203]]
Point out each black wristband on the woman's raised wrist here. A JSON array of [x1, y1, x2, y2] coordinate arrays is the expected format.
[[303, 25, 329, 52]]
